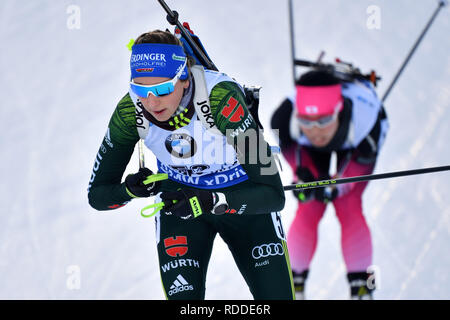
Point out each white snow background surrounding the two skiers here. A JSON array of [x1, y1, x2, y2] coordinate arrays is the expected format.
[[0, 0, 450, 299]]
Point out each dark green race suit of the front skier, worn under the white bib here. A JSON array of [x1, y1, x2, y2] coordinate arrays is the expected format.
[[88, 68, 294, 299]]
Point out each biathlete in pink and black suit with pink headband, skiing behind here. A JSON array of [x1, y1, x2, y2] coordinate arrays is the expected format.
[[271, 70, 388, 299]]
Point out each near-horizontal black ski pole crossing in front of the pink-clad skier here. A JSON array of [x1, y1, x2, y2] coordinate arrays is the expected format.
[[283, 165, 450, 191]]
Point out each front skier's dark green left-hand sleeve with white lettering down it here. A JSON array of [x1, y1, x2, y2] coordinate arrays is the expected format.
[[88, 94, 139, 210]]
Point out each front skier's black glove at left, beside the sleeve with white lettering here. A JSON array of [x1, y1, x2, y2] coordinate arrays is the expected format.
[[125, 168, 161, 198]]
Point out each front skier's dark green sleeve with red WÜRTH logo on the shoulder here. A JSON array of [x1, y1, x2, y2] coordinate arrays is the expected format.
[[209, 82, 285, 214]]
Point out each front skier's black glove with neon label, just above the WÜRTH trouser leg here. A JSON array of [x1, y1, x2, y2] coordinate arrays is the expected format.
[[161, 189, 228, 219]]
